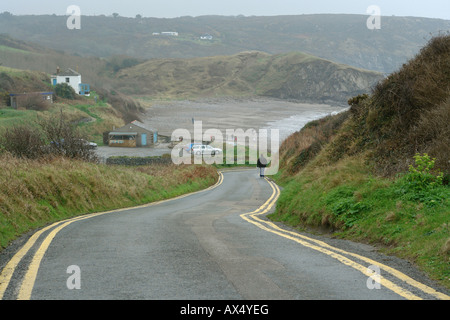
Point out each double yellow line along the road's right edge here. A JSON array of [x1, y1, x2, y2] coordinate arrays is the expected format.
[[241, 179, 450, 300]]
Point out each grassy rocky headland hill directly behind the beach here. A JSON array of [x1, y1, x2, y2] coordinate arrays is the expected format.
[[116, 51, 382, 103]]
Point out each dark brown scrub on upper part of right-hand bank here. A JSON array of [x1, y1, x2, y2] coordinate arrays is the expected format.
[[329, 35, 450, 176]]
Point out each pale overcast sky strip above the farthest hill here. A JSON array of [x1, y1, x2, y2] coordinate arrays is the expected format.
[[0, 0, 450, 20]]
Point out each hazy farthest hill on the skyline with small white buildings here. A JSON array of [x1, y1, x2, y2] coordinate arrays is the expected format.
[[0, 13, 450, 73]]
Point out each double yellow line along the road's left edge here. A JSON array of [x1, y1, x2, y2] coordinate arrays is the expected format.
[[0, 172, 223, 300]]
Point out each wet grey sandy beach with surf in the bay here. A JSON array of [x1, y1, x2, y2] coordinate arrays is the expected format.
[[142, 98, 345, 141]]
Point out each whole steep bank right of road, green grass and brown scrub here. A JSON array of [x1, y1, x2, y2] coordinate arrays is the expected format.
[[271, 36, 450, 288]]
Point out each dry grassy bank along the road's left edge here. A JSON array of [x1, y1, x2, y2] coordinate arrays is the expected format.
[[0, 156, 217, 249]]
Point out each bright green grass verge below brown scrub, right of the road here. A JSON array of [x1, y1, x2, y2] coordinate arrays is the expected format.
[[270, 156, 450, 288]]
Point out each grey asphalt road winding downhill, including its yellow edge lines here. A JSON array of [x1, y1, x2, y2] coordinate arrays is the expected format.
[[0, 170, 450, 300]]
